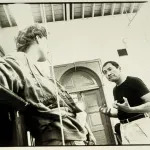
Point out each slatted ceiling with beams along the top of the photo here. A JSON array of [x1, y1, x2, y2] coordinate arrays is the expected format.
[[0, 1, 148, 28]]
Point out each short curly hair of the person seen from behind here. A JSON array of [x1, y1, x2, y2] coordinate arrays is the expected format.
[[16, 24, 47, 52]]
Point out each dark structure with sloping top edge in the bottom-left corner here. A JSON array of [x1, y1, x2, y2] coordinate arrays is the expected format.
[[0, 85, 34, 146]]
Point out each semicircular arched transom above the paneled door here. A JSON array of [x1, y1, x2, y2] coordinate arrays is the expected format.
[[60, 67, 101, 93]]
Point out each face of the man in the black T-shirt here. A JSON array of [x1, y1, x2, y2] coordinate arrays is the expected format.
[[103, 63, 121, 82]]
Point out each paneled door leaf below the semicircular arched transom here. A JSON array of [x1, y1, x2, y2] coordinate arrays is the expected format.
[[82, 90, 108, 145]]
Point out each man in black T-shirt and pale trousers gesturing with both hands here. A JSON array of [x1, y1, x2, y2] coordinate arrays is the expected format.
[[100, 61, 150, 144]]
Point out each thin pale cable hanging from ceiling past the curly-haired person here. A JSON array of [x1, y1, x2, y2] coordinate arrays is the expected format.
[[41, 4, 65, 145]]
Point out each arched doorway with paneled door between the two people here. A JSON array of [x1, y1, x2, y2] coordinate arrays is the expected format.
[[60, 68, 112, 145]]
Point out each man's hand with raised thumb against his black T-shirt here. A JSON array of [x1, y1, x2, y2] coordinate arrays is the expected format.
[[113, 97, 132, 113]]
